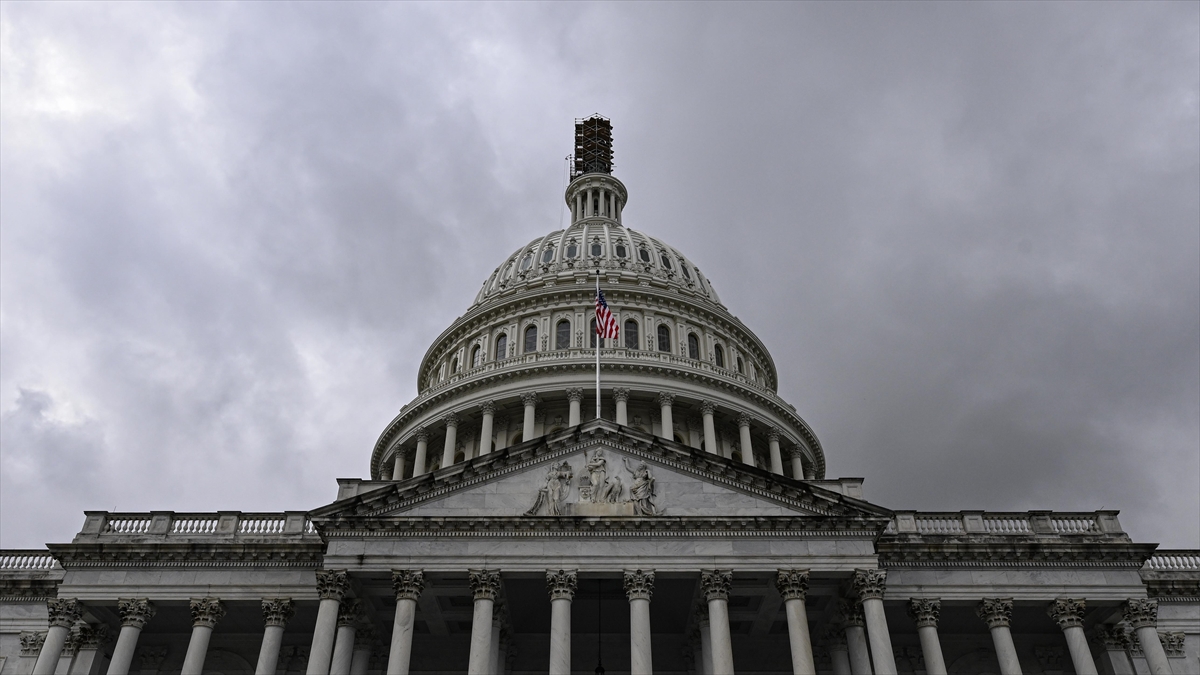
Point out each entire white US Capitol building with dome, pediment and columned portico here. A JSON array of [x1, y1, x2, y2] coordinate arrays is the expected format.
[[0, 117, 1200, 675]]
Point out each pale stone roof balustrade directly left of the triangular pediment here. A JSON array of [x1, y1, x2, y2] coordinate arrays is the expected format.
[[77, 510, 316, 539]]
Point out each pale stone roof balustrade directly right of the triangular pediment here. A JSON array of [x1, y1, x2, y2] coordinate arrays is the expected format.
[[884, 510, 1123, 536]]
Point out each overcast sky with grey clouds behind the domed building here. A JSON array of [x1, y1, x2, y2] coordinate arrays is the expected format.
[[0, 1, 1200, 548]]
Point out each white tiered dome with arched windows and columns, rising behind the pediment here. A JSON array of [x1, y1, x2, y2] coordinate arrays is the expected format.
[[371, 119, 824, 480]]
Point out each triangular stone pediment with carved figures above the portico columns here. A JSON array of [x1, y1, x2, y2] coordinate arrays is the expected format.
[[311, 420, 890, 527]]
